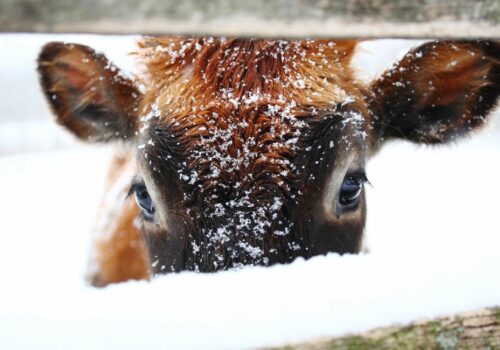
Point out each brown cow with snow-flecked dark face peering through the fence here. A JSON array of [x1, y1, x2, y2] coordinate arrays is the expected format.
[[38, 37, 500, 286]]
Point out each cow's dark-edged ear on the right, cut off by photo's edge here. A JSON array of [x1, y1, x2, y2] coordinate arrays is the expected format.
[[368, 41, 500, 145]]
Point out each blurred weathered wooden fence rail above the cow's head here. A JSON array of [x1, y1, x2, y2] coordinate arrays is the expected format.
[[0, 0, 500, 38]]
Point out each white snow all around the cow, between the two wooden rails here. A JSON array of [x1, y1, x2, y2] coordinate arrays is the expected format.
[[0, 34, 500, 349]]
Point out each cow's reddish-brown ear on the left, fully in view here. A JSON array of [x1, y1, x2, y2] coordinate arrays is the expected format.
[[38, 42, 141, 142]]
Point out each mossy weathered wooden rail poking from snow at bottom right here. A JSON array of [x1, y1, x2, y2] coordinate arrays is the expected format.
[[268, 307, 500, 350]]
